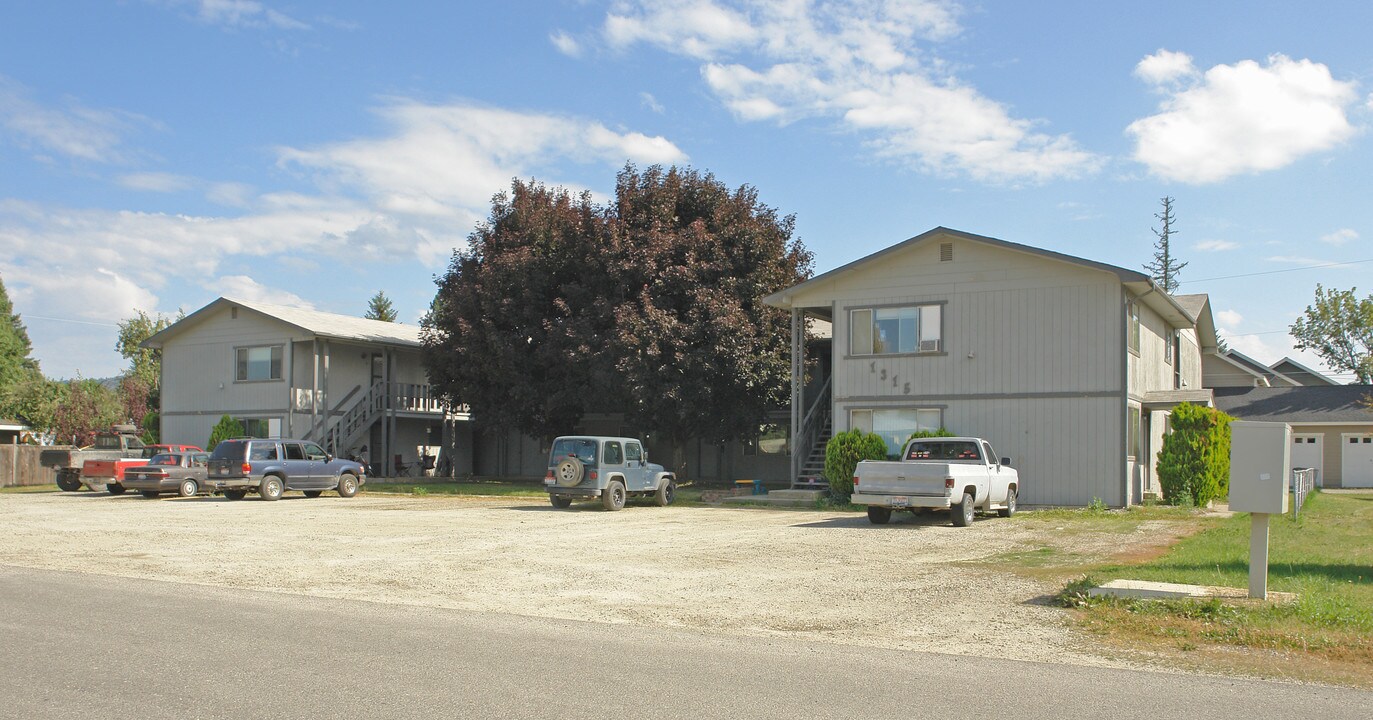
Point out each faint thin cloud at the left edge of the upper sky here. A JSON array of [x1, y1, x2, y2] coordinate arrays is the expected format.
[[0, 76, 155, 162]]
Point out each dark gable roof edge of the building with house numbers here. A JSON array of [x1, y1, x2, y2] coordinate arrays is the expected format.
[[763, 225, 1195, 327]]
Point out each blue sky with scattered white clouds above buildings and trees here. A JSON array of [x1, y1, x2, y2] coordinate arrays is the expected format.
[[0, 0, 1373, 376]]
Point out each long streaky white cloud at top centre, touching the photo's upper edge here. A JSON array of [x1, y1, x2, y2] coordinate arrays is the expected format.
[[603, 0, 1101, 181]]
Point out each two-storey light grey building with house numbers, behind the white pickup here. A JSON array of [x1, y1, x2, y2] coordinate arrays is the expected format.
[[765, 228, 1216, 507]]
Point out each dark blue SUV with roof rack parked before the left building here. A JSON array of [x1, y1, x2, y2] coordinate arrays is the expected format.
[[206, 437, 367, 500]]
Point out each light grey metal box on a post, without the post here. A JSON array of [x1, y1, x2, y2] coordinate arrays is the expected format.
[[1230, 420, 1292, 515]]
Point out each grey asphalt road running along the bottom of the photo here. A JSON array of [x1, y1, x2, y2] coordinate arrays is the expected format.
[[0, 566, 1373, 720]]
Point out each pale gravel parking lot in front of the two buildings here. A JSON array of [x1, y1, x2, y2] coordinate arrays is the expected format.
[[0, 492, 1169, 665]]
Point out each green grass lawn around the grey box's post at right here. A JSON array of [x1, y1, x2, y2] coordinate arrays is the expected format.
[[1063, 493, 1373, 687]]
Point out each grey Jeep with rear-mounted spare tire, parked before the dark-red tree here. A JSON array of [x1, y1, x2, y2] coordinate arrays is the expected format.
[[544, 436, 677, 510]]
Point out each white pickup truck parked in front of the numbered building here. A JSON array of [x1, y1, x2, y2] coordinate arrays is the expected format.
[[853, 437, 1020, 528]]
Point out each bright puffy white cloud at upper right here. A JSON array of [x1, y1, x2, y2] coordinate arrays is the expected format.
[[1126, 51, 1357, 184]]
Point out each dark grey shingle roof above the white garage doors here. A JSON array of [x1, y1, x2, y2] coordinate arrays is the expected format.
[[1215, 385, 1373, 425]]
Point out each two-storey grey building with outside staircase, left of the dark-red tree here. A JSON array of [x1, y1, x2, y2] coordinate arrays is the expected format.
[[144, 297, 471, 474]]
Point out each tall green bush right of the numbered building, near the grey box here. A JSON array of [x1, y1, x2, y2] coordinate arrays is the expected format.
[[1157, 403, 1234, 507]]
